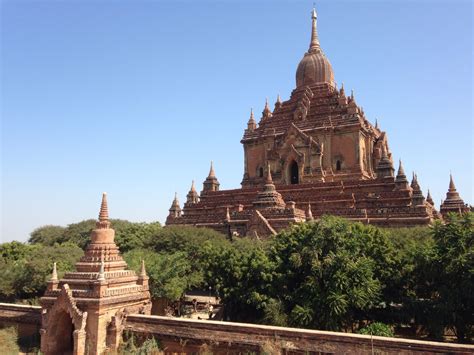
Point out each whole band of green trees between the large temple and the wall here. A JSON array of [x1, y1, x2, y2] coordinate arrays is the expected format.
[[0, 213, 474, 342]]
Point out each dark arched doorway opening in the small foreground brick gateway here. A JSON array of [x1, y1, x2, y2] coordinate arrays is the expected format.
[[49, 310, 74, 354]]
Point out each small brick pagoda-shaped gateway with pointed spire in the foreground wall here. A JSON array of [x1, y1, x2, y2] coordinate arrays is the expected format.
[[40, 193, 151, 355]]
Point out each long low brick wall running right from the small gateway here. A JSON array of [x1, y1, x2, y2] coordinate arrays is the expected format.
[[125, 315, 474, 354]]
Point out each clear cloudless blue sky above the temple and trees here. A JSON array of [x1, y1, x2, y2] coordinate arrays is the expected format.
[[1, 0, 473, 241]]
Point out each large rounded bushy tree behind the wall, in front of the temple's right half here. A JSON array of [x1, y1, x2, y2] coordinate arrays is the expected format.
[[270, 216, 389, 330]]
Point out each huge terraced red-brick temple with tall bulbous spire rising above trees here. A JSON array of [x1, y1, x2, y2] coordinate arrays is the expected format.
[[166, 9, 469, 237]]
